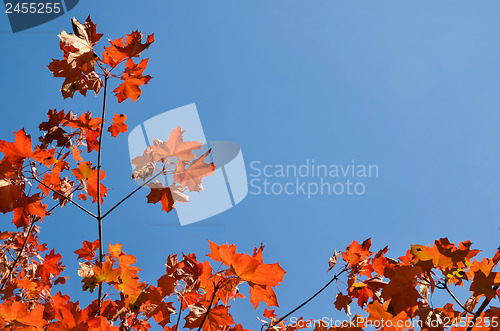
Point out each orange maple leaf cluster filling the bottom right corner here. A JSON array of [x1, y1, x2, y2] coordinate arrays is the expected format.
[[298, 238, 500, 330]]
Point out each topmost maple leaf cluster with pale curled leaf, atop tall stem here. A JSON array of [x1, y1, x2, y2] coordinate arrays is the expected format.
[[48, 16, 154, 102]]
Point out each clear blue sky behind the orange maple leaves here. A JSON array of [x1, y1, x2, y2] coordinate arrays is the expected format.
[[0, 0, 500, 329]]
